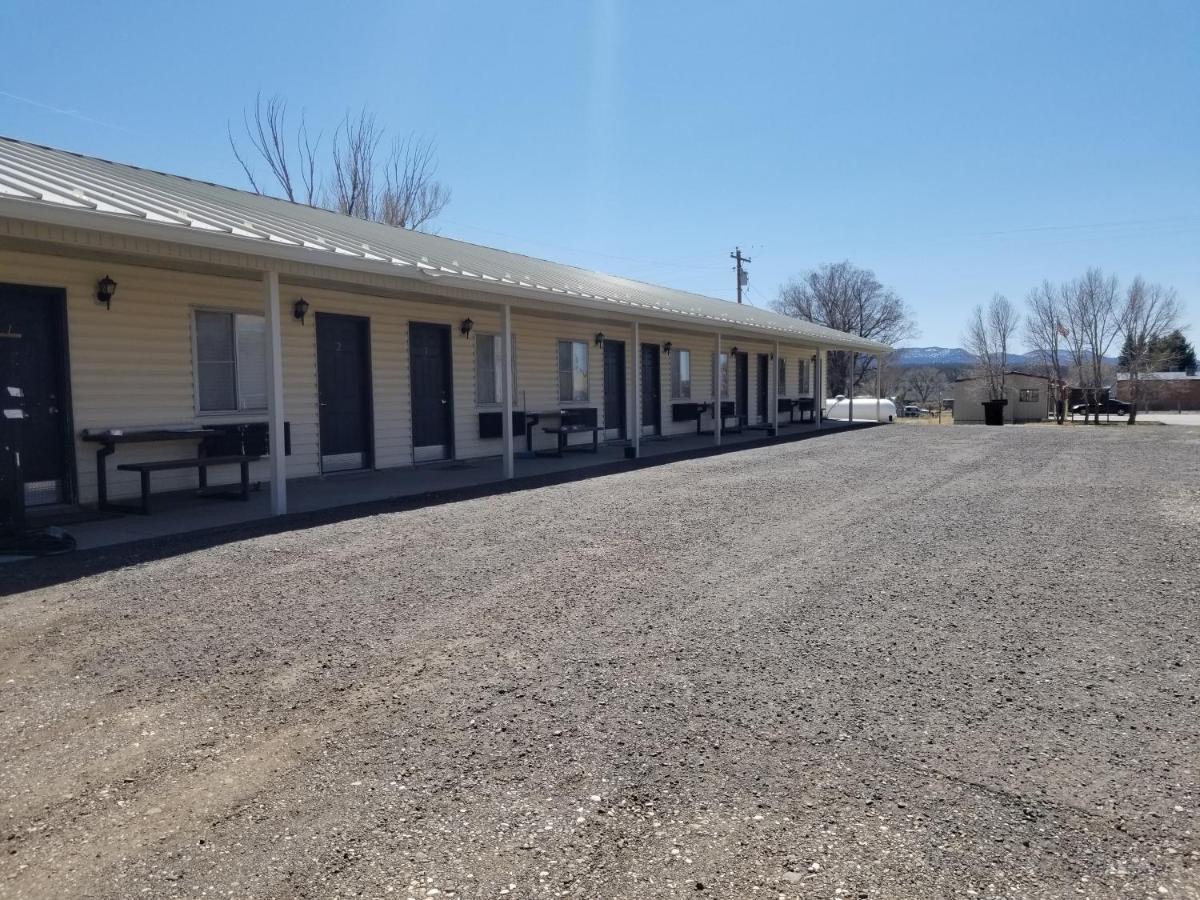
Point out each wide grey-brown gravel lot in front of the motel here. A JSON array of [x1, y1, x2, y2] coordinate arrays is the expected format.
[[0, 426, 1200, 900]]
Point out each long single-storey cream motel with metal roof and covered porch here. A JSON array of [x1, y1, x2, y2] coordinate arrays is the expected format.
[[0, 139, 888, 545]]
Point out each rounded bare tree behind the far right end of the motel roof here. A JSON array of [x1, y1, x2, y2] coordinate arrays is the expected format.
[[772, 260, 916, 395]]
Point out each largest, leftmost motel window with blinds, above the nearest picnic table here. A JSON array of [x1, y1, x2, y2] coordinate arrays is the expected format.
[[193, 310, 266, 413]]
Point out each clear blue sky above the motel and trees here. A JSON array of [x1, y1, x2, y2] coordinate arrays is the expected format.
[[0, 0, 1200, 346]]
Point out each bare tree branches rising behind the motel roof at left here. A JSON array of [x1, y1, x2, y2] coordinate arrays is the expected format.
[[229, 95, 450, 228]]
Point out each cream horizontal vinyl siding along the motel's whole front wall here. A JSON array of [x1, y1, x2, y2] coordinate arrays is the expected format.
[[0, 250, 844, 503]]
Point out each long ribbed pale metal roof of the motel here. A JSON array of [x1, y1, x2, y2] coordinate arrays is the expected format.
[[0, 137, 889, 353]]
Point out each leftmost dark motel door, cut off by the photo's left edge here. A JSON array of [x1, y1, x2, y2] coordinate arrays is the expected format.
[[0, 284, 74, 506]]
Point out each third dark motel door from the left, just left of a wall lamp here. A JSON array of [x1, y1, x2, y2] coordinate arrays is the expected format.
[[408, 322, 454, 462]]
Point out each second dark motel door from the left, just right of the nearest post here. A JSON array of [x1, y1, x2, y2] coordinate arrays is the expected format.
[[317, 312, 372, 472]]
